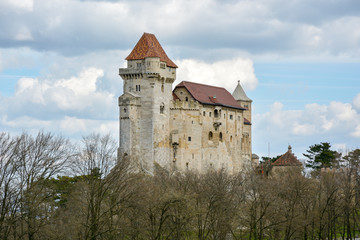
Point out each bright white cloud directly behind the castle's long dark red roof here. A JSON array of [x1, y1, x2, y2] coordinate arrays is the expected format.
[[174, 58, 258, 93]]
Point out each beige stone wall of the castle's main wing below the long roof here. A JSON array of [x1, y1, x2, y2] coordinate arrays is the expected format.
[[170, 91, 250, 173]]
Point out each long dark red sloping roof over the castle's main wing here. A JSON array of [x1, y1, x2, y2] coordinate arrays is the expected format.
[[174, 81, 245, 110]]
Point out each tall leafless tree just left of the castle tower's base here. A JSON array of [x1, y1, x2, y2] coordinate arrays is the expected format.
[[68, 134, 136, 239]]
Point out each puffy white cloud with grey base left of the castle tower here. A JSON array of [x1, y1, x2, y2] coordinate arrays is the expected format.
[[7, 68, 117, 119]]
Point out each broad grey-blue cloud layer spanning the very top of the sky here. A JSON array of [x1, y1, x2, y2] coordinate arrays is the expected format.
[[0, 0, 360, 61]]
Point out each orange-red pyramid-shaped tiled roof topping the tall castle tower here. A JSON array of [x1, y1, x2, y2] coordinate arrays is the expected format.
[[125, 33, 177, 68]]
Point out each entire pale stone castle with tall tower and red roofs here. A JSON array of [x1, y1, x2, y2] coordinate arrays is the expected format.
[[118, 33, 252, 174]]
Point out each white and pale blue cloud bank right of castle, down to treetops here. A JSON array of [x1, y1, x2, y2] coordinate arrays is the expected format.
[[252, 98, 360, 158]]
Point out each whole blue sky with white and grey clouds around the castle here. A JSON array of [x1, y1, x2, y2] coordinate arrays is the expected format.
[[0, 0, 360, 159]]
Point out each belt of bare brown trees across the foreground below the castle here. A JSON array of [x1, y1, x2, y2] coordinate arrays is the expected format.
[[0, 132, 360, 240]]
